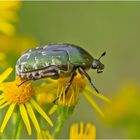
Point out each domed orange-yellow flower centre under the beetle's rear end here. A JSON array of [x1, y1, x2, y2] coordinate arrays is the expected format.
[[3, 77, 35, 104]]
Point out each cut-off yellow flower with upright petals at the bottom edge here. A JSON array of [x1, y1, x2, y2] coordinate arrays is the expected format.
[[70, 122, 96, 139]]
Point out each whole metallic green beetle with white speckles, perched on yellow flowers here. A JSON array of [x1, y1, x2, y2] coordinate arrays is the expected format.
[[16, 44, 106, 93]]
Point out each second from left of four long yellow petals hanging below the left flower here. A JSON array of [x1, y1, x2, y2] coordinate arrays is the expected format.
[[19, 104, 32, 135]]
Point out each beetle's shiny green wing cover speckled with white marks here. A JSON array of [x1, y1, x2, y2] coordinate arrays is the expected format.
[[16, 47, 68, 75]]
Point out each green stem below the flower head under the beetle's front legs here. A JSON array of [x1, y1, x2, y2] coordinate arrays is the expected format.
[[53, 116, 66, 138]]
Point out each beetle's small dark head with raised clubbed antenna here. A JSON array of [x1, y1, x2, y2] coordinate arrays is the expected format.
[[92, 52, 106, 73]]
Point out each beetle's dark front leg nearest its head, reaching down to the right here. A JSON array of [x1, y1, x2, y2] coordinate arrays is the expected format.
[[78, 67, 99, 93]]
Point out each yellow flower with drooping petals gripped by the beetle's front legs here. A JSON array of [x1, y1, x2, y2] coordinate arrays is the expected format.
[[38, 73, 110, 116]]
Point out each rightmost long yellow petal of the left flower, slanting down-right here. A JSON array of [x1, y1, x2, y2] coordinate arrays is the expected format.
[[30, 99, 53, 126]]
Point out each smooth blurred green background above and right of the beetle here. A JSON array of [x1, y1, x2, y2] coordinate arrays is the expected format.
[[18, 2, 140, 94]]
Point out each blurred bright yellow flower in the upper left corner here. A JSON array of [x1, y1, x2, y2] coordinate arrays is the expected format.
[[0, 0, 20, 35]]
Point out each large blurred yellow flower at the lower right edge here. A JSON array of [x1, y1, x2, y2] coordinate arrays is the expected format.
[[103, 80, 140, 139]]
